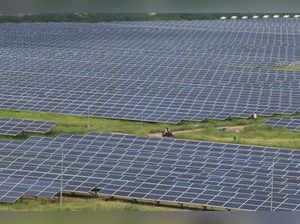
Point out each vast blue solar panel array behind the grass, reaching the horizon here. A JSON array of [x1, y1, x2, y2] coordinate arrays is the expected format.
[[0, 19, 300, 123]]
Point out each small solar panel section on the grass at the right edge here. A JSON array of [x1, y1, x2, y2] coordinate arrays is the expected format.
[[264, 117, 300, 131]]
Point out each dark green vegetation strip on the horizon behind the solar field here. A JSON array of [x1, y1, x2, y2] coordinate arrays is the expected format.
[[0, 13, 300, 23]]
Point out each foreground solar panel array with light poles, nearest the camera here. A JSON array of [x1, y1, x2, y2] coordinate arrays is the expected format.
[[0, 133, 300, 211]]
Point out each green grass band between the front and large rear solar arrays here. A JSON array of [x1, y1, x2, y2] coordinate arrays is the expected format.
[[0, 110, 300, 149]]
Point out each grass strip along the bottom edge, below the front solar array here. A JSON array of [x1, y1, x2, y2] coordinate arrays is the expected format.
[[0, 199, 184, 224]]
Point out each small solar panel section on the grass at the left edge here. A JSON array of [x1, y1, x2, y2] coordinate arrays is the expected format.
[[0, 118, 56, 136]]
